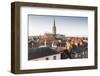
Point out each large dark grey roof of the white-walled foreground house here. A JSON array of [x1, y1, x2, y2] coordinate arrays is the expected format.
[[28, 47, 59, 60]]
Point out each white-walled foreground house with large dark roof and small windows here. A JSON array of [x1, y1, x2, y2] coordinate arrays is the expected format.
[[28, 47, 61, 60]]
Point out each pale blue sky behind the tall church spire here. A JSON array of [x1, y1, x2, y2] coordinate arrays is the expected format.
[[28, 15, 88, 37]]
